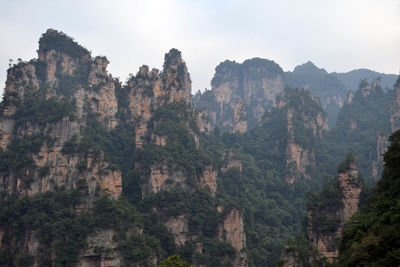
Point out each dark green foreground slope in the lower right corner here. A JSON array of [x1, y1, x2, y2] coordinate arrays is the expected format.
[[339, 131, 400, 266]]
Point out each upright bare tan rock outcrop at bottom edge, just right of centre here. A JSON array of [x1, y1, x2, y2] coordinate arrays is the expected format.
[[218, 209, 247, 267]]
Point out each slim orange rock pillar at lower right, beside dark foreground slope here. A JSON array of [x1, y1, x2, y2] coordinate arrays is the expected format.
[[307, 158, 362, 262]]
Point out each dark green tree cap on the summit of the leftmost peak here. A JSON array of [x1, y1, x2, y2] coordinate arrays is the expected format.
[[39, 30, 90, 58]]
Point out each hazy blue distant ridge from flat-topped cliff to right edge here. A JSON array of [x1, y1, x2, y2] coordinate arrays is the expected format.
[[194, 58, 397, 132]]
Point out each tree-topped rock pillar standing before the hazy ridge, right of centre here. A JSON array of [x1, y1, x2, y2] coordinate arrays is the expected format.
[[265, 89, 327, 183]]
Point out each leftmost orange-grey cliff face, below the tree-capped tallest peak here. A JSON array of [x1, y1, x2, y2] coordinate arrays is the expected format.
[[0, 30, 122, 201]]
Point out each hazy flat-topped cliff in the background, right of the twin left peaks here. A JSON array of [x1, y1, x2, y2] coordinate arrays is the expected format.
[[194, 58, 284, 133]]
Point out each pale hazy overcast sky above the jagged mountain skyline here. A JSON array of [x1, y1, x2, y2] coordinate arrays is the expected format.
[[0, 0, 400, 92]]
